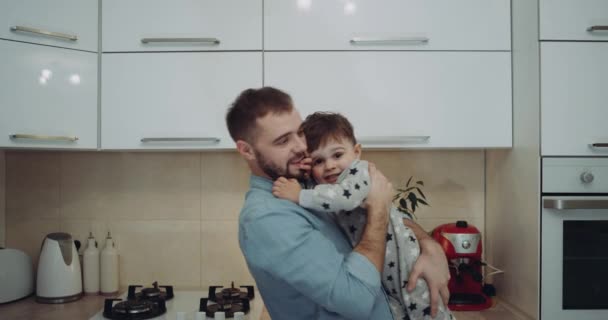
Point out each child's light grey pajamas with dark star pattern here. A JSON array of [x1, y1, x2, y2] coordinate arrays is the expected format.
[[299, 160, 455, 320]]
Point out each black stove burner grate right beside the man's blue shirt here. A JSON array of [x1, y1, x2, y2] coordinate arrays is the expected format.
[[199, 282, 254, 318]]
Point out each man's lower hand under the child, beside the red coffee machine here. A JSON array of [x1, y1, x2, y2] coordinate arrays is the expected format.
[[407, 235, 450, 318]]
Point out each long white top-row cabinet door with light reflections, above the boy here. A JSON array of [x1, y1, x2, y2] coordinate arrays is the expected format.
[[264, 0, 511, 50]]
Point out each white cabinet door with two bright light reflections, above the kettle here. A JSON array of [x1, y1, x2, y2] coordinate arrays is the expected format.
[[0, 40, 97, 149]]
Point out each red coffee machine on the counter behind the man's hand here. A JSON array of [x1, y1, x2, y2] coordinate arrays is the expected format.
[[433, 221, 492, 311]]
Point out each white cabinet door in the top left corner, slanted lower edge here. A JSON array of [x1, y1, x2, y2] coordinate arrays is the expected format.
[[0, 0, 98, 52]]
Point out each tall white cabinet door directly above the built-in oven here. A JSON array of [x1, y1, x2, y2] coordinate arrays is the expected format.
[[541, 42, 608, 156]]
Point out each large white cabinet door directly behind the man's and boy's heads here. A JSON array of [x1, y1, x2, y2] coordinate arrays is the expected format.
[[264, 51, 512, 148]]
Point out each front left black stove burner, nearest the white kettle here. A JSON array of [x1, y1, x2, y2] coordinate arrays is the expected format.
[[103, 299, 167, 320]]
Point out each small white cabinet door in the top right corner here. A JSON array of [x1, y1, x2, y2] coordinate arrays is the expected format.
[[540, 0, 608, 41]]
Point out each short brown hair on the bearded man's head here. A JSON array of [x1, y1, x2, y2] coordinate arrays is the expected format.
[[226, 87, 293, 143]]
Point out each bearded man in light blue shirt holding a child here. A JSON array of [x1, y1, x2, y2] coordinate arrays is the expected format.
[[226, 87, 449, 320]]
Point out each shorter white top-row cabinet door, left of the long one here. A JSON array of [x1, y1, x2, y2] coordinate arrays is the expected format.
[[102, 0, 262, 52]]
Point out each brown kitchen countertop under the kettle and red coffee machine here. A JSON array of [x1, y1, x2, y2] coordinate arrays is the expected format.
[[0, 295, 527, 320]]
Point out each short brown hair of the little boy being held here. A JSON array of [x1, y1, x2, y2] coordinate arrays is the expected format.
[[300, 112, 357, 153]]
